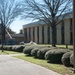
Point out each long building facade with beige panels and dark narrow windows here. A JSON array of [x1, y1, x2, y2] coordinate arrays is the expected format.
[[23, 16, 73, 44]]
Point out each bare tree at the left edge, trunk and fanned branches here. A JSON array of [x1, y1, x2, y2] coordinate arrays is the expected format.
[[0, 0, 23, 51]]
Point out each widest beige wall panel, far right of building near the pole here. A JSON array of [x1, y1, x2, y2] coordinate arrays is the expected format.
[[64, 19, 70, 44]]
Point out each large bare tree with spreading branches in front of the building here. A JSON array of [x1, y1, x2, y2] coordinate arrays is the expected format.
[[23, 0, 72, 47]]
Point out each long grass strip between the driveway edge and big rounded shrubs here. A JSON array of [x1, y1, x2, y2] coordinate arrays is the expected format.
[[15, 55, 75, 75]]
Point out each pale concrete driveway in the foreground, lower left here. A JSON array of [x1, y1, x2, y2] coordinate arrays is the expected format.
[[0, 55, 60, 75]]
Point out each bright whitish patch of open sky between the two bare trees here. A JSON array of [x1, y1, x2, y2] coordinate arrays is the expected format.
[[10, 19, 32, 33]]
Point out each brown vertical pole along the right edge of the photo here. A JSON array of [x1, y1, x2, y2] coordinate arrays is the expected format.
[[73, 0, 75, 73]]
